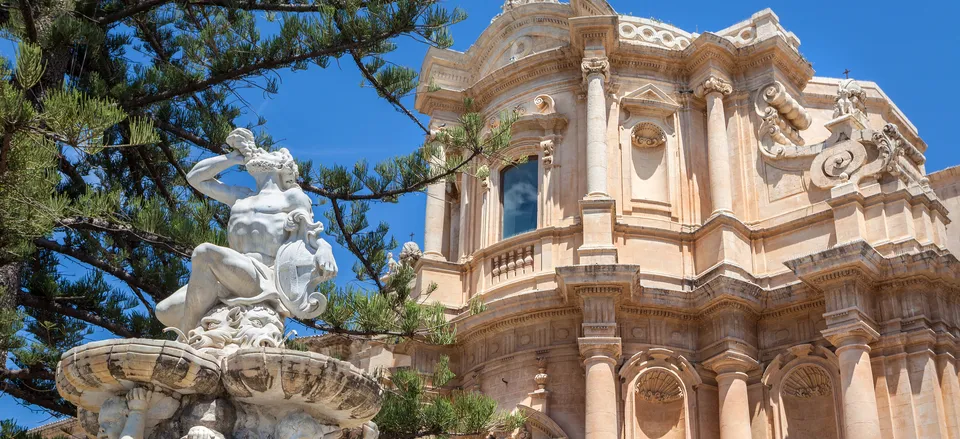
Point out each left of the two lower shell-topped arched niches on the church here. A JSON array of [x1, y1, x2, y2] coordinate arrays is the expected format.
[[620, 348, 703, 439]]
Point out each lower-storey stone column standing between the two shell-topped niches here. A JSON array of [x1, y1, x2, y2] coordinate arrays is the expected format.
[[704, 351, 757, 439]]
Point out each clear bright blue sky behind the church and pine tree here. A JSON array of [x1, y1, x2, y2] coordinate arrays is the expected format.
[[7, 0, 960, 427]]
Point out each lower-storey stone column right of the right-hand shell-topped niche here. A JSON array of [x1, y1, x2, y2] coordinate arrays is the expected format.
[[823, 323, 880, 439]]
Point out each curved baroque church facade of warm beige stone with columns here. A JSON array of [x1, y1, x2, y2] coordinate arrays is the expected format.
[[313, 0, 960, 439]]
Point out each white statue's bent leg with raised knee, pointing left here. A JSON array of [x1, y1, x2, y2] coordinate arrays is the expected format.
[[180, 243, 262, 332]]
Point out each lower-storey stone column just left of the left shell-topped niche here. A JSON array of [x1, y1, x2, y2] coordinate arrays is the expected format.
[[579, 337, 620, 439]]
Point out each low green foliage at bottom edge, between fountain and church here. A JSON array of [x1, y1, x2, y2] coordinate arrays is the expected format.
[[373, 357, 526, 439]]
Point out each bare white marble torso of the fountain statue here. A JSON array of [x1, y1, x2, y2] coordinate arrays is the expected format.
[[227, 189, 309, 265]]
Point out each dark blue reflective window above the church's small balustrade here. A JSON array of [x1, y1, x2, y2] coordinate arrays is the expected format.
[[500, 156, 539, 238]]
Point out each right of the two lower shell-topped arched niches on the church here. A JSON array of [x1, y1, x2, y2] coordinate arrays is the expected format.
[[761, 344, 843, 439]]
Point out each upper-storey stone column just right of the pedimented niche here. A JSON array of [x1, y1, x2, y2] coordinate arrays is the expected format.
[[695, 76, 733, 214]]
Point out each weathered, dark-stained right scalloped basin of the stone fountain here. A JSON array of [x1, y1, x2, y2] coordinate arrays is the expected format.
[[223, 348, 382, 428]]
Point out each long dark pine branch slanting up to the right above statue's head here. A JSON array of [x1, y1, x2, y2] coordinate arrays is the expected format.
[[123, 29, 410, 108]]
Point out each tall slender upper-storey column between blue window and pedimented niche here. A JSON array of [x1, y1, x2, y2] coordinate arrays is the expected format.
[[580, 57, 610, 198]]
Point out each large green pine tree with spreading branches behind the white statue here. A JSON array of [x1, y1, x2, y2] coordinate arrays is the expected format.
[[0, 0, 516, 435]]
